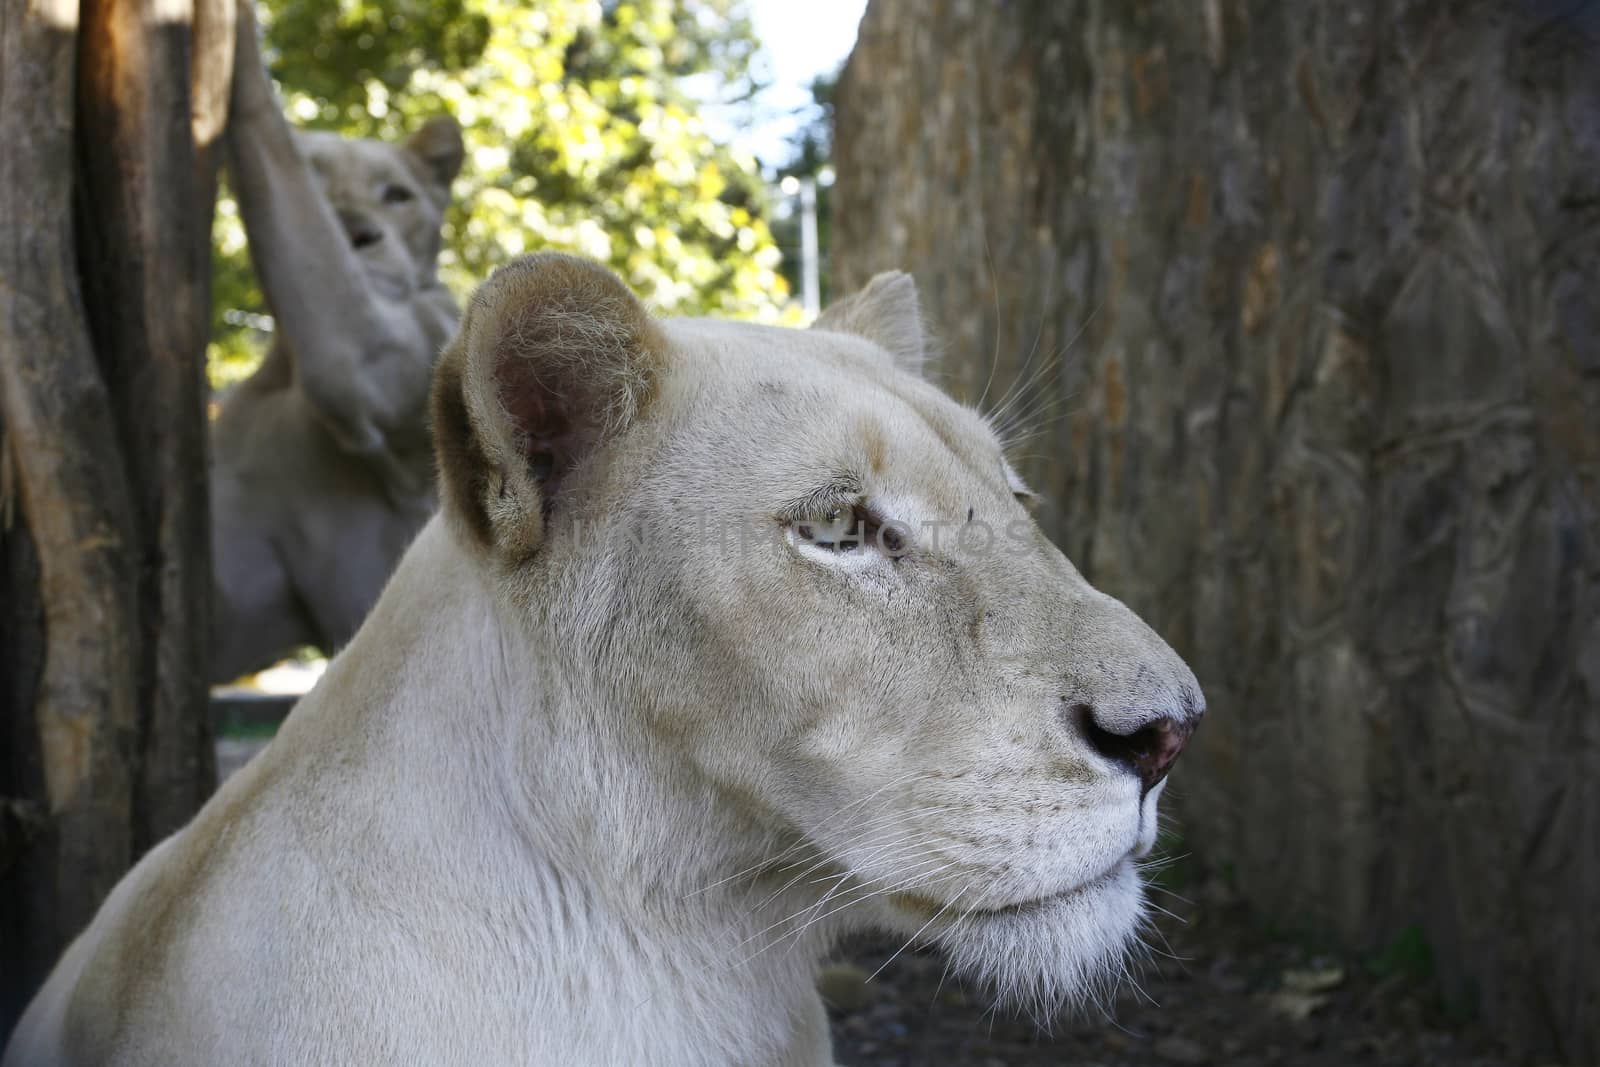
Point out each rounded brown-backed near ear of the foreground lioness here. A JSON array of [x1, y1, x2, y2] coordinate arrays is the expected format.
[[432, 253, 662, 561]]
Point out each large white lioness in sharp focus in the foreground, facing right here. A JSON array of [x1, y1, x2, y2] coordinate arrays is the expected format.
[[5, 254, 1202, 1067]]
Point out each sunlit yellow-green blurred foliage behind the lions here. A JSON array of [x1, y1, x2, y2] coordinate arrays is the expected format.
[[211, 0, 789, 384]]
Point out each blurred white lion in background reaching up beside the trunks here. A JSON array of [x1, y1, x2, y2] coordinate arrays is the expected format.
[[210, 2, 464, 681]]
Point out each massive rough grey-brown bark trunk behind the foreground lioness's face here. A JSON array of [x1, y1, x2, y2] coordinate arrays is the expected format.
[[834, 0, 1600, 1062]]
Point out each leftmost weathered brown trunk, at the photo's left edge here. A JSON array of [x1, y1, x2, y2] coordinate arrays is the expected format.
[[0, 0, 138, 1023]]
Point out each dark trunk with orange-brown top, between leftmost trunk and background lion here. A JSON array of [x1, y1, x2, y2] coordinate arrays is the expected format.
[[75, 0, 216, 853]]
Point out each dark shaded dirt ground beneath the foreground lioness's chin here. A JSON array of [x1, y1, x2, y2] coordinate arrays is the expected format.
[[822, 888, 1536, 1067]]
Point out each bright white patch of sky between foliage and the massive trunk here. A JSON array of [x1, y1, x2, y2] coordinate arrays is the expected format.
[[706, 0, 867, 168]]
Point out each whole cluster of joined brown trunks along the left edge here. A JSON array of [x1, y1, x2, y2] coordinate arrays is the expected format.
[[0, 0, 232, 1032]]
